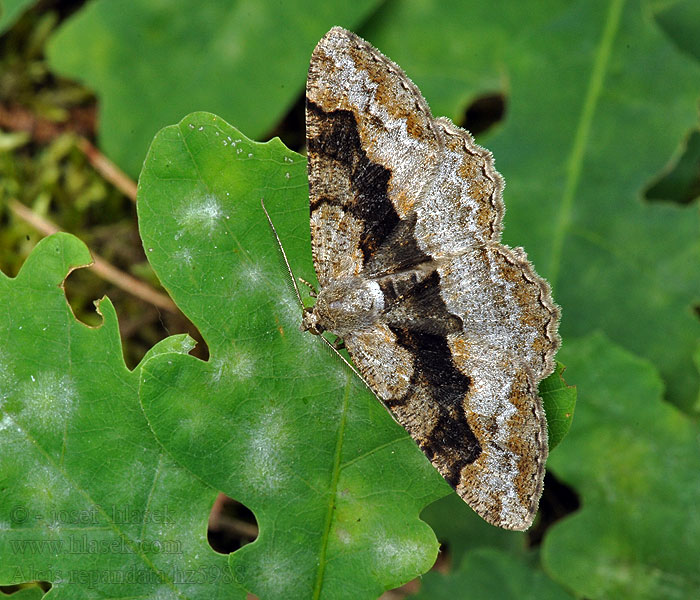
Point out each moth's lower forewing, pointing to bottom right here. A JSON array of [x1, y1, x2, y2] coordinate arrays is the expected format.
[[345, 324, 547, 530]]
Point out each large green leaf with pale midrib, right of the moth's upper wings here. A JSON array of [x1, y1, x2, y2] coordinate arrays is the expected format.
[[360, 0, 700, 410]]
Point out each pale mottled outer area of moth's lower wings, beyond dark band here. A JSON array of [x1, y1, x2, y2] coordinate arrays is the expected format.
[[438, 245, 560, 529]]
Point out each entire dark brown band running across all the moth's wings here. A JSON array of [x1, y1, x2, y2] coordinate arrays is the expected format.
[[306, 99, 482, 487]]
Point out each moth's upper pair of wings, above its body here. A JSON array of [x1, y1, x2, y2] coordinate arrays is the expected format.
[[306, 27, 503, 286]]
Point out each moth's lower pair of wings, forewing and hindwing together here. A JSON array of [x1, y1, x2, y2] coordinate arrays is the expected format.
[[345, 247, 558, 530]]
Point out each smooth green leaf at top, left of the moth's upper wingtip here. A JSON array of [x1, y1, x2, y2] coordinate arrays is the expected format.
[[47, 0, 378, 175]]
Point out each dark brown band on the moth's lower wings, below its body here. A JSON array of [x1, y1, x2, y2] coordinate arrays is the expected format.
[[390, 326, 482, 488]]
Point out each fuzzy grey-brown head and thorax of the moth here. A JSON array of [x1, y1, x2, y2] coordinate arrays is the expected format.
[[301, 277, 384, 338]]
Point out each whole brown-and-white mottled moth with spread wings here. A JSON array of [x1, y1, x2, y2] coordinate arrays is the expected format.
[[276, 27, 560, 530]]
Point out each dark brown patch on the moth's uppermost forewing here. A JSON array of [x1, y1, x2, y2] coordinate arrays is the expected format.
[[306, 99, 399, 263]]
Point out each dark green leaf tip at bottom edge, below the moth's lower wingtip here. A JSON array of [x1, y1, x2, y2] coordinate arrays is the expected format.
[[412, 548, 573, 600]]
